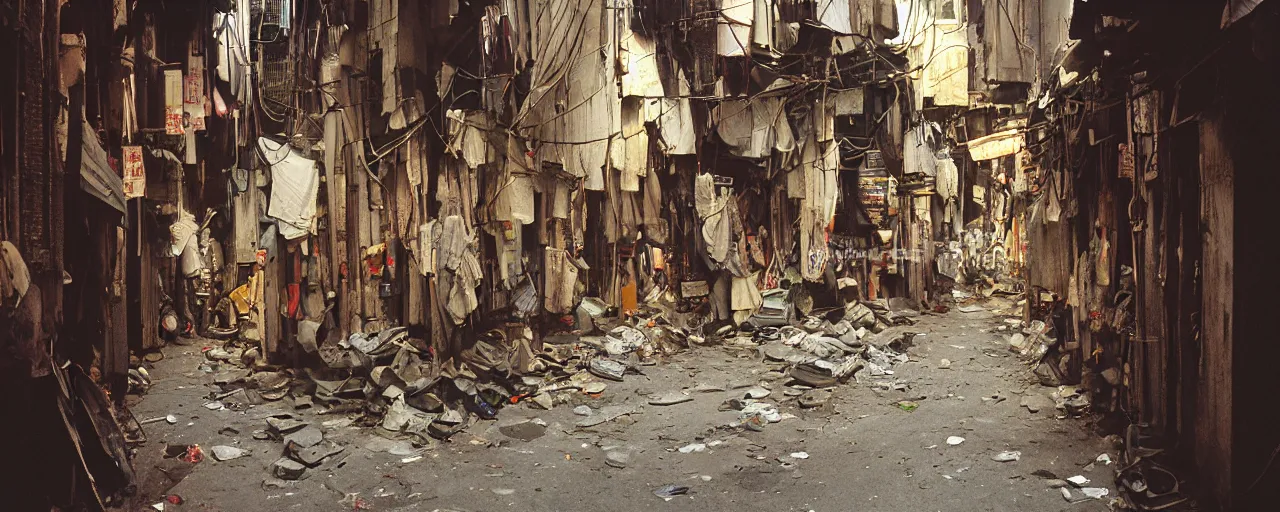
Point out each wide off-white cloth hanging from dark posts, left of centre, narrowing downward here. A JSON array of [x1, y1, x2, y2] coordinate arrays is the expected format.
[[257, 137, 320, 239]]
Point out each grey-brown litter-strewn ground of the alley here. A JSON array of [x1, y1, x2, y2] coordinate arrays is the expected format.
[[122, 305, 1119, 512]]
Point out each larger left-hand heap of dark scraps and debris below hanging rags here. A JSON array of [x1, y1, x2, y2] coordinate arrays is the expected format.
[[186, 300, 687, 453]]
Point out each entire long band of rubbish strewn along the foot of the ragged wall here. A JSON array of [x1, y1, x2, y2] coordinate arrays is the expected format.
[[137, 280, 918, 481]]
